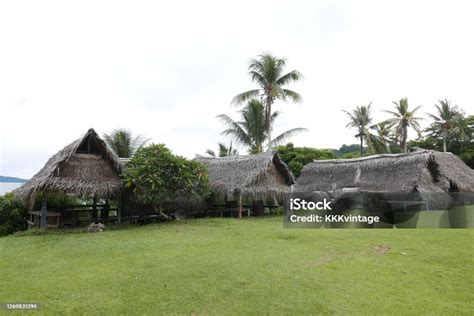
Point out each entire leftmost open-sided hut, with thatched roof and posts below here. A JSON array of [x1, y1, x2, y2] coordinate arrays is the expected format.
[[13, 129, 123, 228]]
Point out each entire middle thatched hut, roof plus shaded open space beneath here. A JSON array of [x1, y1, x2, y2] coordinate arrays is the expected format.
[[196, 151, 295, 218]]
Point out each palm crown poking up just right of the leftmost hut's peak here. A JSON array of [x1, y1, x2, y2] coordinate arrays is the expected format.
[[103, 128, 149, 158]]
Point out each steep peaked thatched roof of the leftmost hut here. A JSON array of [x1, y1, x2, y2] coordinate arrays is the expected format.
[[13, 129, 122, 202]]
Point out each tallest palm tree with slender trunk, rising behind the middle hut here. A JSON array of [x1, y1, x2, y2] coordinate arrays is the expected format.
[[232, 53, 302, 142]]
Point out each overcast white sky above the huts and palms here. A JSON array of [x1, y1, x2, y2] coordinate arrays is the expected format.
[[0, 0, 474, 178]]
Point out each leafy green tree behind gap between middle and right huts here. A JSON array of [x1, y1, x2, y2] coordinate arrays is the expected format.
[[275, 143, 336, 177]]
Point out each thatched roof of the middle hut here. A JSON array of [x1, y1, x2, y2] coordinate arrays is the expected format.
[[196, 151, 295, 200]]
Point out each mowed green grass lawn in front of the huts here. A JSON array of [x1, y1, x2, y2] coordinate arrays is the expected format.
[[0, 217, 474, 315]]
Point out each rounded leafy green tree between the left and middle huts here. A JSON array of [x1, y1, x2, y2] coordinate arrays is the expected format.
[[122, 144, 211, 218]]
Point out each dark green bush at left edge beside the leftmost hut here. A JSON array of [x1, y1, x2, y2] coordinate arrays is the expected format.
[[0, 193, 27, 236]]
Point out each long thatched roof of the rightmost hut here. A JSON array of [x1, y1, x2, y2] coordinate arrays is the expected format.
[[294, 150, 474, 192]]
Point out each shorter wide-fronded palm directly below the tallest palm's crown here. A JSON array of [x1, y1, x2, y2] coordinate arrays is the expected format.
[[217, 99, 306, 154]]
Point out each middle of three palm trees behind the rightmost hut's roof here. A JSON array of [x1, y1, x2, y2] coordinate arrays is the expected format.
[[384, 98, 422, 153]]
